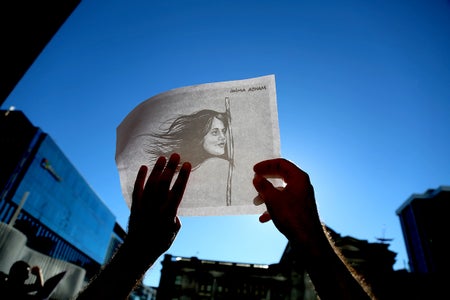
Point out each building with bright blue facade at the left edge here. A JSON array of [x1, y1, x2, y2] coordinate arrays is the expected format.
[[0, 110, 125, 296]]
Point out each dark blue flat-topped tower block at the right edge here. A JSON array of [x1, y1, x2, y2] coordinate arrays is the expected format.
[[396, 186, 450, 274]]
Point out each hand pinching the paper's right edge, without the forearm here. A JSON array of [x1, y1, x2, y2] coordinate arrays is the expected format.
[[253, 158, 323, 243]]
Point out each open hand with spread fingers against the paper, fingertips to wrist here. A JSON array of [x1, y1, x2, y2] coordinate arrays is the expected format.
[[126, 153, 191, 260]]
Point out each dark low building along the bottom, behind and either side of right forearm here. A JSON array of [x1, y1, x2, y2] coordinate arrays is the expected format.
[[156, 228, 397, 300]]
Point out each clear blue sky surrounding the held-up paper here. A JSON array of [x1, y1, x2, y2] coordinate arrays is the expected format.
[[2, 0, 450, 285]]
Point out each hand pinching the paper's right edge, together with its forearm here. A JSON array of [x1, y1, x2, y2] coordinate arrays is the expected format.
[[253, 158, 371, 300]]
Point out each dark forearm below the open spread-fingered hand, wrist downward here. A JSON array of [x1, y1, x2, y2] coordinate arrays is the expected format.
[[76, 242, 161, 300]]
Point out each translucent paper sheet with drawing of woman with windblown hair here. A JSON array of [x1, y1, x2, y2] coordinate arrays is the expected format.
[[116, 75, 280, 216]]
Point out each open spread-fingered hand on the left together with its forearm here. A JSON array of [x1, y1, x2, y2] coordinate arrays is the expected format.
[[76, 154, 191, 300]]
